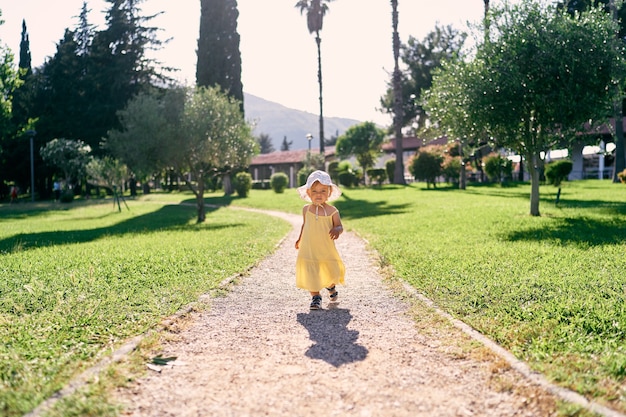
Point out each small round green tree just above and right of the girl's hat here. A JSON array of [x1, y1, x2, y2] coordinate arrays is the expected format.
[[335, 122, 385, 179]]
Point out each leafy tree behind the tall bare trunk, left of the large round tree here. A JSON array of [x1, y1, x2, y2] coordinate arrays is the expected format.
[[380, 26, 467, 130]]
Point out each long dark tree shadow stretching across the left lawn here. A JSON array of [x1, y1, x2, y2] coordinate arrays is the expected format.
[[0, 205, 238, 255]]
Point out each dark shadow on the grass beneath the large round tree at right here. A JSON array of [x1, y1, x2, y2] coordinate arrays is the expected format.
[[504, 217, 626, 247]]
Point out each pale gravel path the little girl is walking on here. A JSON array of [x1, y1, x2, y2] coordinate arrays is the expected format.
[[117, 213, 556, 417]]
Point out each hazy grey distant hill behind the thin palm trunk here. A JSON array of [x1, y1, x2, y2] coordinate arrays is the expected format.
[[243, 93, 361, 151]]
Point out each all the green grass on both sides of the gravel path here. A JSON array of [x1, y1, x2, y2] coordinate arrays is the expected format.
[[0, 180, 626, 416]]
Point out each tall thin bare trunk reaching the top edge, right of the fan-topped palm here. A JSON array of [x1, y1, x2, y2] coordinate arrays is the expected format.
[[391, 0, 406, 184]]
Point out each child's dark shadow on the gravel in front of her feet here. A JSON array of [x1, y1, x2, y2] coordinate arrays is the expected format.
[[298, 308, 368, 368]]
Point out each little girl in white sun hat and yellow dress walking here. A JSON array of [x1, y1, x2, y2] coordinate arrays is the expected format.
[[296, 171, 346, 310]]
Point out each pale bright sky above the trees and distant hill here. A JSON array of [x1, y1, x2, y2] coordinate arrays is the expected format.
[[0, 0, 500, 125]]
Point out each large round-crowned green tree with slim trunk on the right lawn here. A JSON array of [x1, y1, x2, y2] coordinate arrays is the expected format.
[[422, 2, 626, 216]]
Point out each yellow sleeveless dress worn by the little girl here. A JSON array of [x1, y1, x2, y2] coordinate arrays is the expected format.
[[296, 208, 346, 292]]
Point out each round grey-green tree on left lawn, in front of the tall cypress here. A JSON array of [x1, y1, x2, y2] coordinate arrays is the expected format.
[[106, 87, 258, 223]]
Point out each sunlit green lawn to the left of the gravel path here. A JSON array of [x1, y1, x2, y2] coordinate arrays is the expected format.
[[0, 195, 289, 417]]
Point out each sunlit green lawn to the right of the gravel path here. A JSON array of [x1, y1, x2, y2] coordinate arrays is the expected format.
[[221, 180, 626, 412]]
